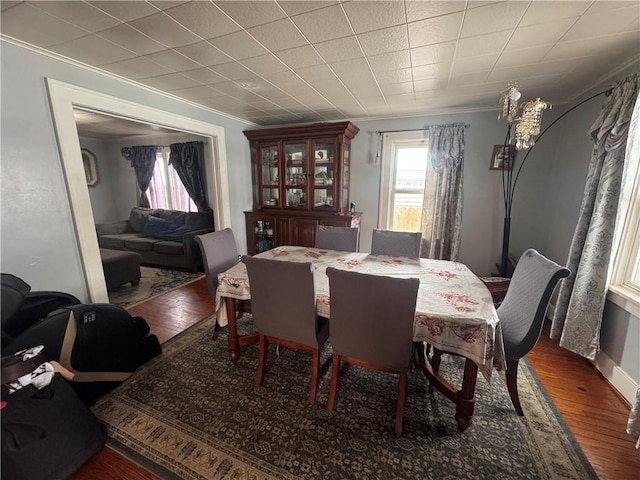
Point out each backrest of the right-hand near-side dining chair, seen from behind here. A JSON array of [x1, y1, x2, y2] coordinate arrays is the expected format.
[[327, 267, 420, 371]]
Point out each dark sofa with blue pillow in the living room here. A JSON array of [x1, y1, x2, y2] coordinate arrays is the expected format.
[[96, 207, 213, 271]]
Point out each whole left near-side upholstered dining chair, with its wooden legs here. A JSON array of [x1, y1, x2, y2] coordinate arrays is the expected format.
[[242, 255, 329, 404]]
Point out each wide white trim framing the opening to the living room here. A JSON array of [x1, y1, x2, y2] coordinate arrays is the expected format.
[[46, 78, 231, 302]]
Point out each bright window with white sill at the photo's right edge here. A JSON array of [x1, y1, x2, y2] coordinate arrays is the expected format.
[[608, 102, 640, 317]]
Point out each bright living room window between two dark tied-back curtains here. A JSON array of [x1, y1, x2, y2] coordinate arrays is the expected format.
[[147, 147, 198, 212]]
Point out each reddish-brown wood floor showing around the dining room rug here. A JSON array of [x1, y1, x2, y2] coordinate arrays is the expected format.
[[71, 279, 640, 480]]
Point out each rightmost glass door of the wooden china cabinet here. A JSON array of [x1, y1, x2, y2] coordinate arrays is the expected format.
[[312, 140, 338, 210]]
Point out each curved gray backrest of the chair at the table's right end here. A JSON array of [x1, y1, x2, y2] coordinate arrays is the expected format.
[[498, 249, 571, 360]]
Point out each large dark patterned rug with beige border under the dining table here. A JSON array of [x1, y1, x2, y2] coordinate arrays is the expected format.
[[93, 316, 597, 480]]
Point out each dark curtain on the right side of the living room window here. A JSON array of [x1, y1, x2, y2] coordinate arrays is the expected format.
[[169, 142, 210, 212]]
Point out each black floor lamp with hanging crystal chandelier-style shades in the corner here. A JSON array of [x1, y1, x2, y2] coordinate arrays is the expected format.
[[497, 82, 551, 277]]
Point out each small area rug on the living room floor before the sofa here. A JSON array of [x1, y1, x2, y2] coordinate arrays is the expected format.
[[109, 267, 204, 308]]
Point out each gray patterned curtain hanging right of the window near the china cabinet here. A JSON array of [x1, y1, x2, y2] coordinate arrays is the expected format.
[[421, 124, 465, 261]]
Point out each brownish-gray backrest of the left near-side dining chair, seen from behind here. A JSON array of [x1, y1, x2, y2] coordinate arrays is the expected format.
[[242, 255, 320, 347]]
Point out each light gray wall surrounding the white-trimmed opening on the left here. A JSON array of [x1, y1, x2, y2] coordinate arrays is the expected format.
[[0, 41, 252, 299]]
